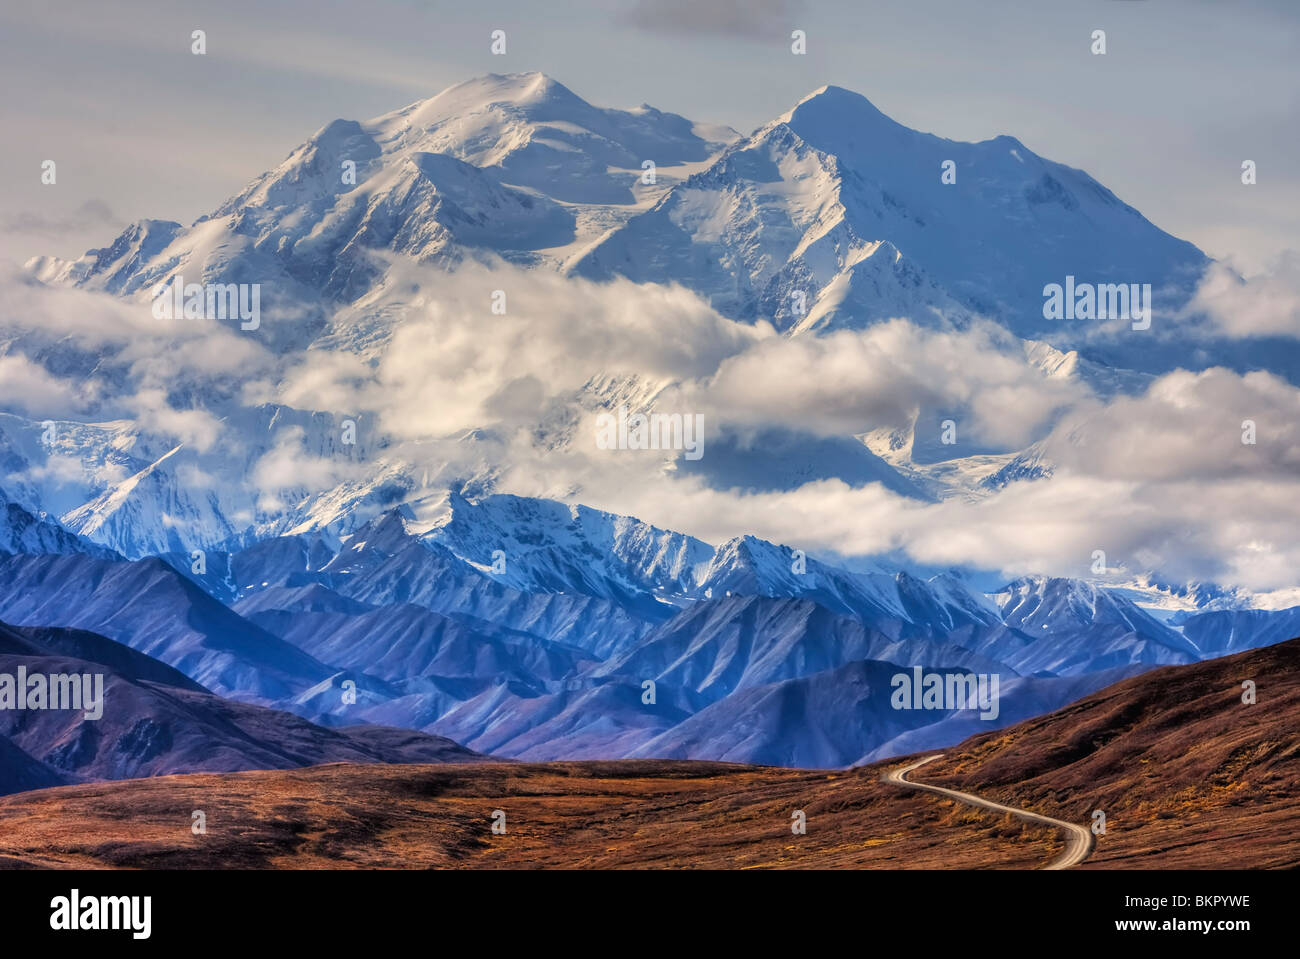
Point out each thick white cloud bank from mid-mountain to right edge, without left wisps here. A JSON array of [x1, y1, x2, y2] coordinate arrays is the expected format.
[[261, 261, 1300, 589]]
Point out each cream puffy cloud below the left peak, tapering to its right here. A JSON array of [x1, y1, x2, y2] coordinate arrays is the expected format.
[[277, 262, 759, 439]]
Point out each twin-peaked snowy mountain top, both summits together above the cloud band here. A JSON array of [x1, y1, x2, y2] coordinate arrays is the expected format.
[[31, 73, 1208, 356]]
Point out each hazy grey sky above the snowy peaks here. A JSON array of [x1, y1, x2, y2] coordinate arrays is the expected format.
[[0, 0, 1300, 268]]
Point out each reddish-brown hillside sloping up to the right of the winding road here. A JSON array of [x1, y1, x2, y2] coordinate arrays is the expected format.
[[924, 639, 1300, 868]]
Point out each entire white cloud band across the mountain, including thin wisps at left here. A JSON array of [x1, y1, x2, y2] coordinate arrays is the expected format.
[[0, 262, 1300, 590]]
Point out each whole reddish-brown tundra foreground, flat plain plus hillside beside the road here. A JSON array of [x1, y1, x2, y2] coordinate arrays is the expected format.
[[0, 639, 1300, 868]]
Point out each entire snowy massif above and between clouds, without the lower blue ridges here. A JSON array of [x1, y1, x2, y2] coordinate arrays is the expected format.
[[0, 74, 1227, 561]]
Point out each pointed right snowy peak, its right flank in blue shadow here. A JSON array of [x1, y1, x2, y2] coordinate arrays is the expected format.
[[576, 86, 1205, 337]]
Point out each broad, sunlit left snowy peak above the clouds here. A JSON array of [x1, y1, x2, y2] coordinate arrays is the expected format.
[[30, 73, 736, 348]]
